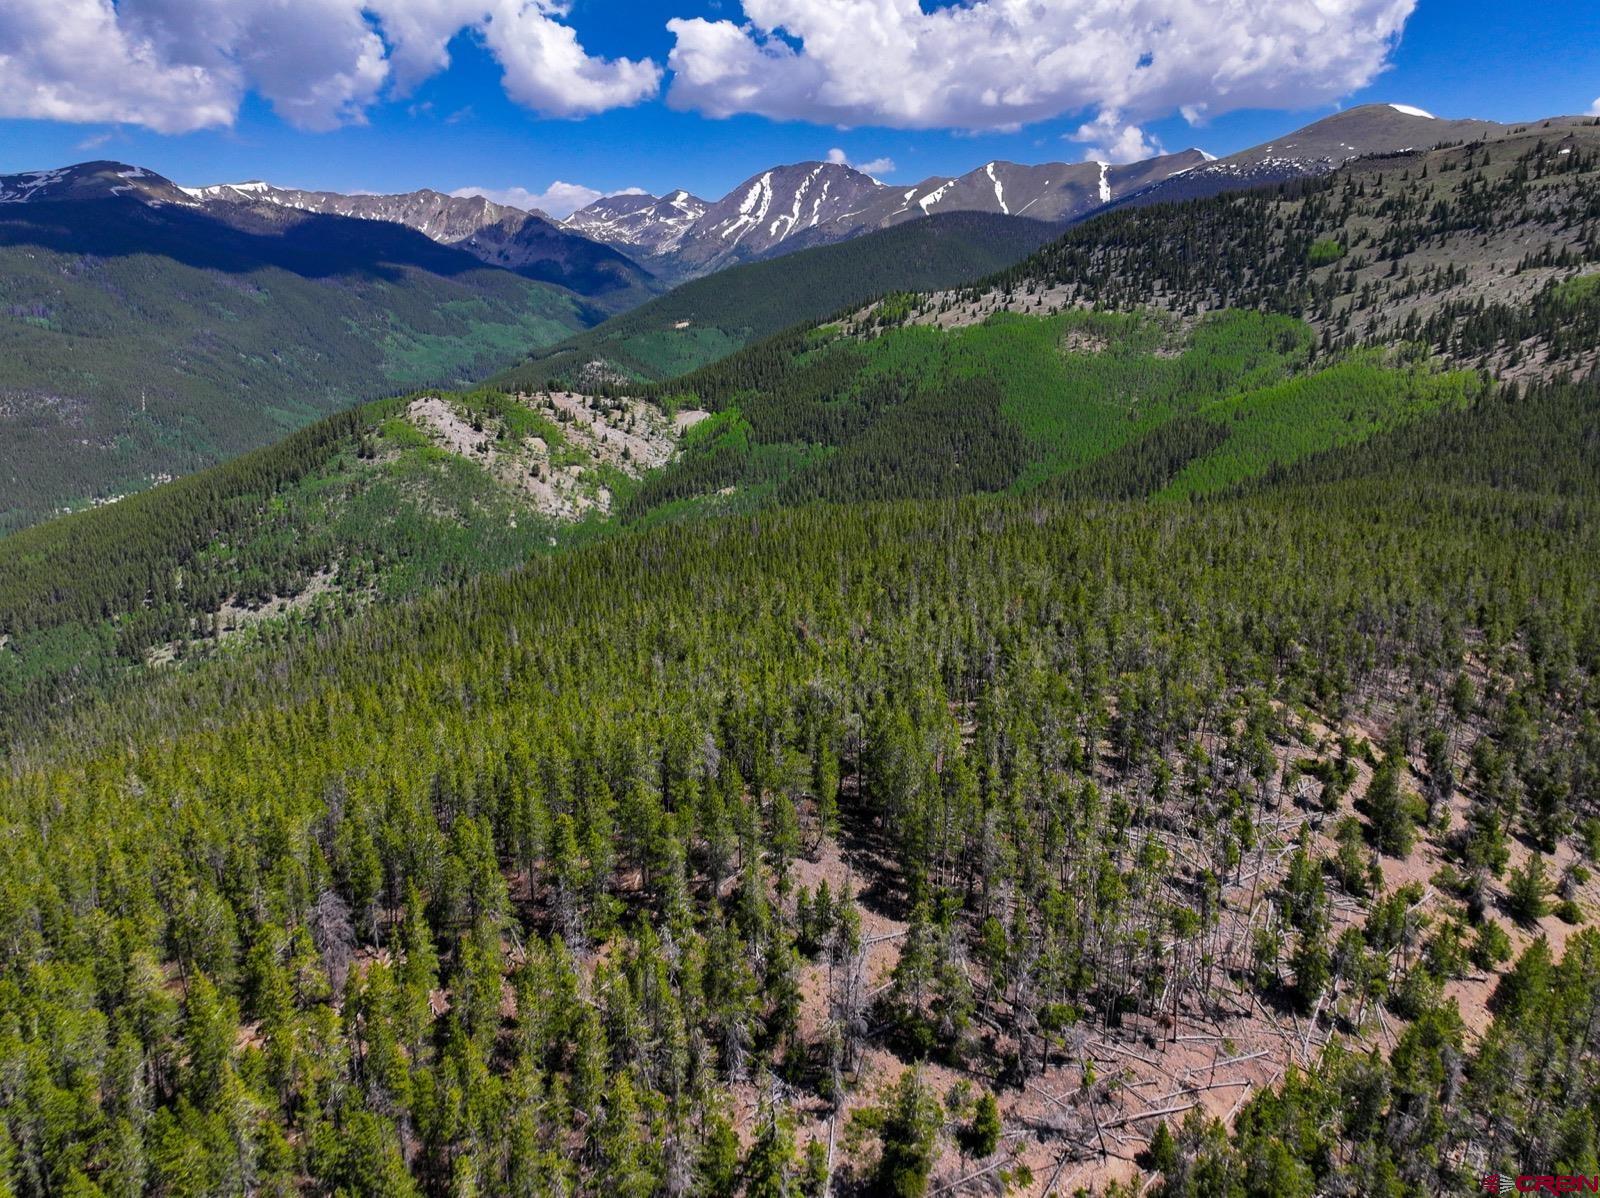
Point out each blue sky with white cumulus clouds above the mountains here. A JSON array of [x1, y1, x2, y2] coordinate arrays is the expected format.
[[0, 0, 1600, 214]]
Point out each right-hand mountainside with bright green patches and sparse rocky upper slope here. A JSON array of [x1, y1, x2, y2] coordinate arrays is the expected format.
[[601, 120, 1600, 517]]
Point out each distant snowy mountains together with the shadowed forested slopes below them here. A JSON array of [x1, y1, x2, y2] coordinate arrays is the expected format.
[[0, 106, 1548, 528]]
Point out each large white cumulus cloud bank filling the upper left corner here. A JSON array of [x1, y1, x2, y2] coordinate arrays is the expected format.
[[0, 0, 661, 133]]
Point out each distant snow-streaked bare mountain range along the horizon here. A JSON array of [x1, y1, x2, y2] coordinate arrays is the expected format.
[[0, 104, 1502, 294]]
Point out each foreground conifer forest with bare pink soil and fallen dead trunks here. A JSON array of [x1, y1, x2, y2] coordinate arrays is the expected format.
[[0, 369, 1600, 1198]]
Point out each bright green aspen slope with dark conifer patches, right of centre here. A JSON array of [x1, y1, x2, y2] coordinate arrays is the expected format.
[[617, 312, 1480, 518]]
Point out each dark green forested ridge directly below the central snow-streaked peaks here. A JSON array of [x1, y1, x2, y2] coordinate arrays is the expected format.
[[493, 213, 1053, 387]]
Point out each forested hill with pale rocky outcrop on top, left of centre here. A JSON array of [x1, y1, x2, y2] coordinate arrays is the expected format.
[[0, 383, 698, 741]]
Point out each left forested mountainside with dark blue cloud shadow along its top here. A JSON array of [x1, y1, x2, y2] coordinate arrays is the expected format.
[[0, 197, 633, 533]]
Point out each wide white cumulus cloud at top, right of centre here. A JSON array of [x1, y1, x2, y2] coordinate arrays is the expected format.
[[667, 0, 1416, 136]]
